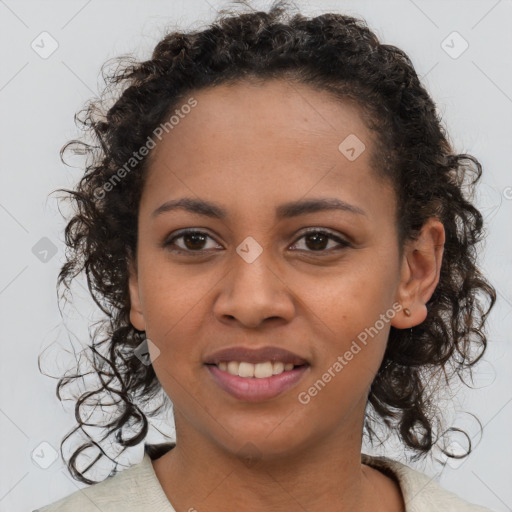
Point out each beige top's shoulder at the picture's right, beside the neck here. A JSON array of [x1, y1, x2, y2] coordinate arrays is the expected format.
[[361, 453, 491, 512]]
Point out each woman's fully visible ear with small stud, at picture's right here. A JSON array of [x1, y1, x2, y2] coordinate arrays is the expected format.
[[391, 218, 445, 329]]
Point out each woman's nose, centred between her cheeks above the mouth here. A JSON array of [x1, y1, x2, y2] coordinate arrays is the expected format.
[[213, 247, 295, 329]]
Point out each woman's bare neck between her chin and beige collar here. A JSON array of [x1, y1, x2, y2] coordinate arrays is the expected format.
[[148, 419, 403, 512]]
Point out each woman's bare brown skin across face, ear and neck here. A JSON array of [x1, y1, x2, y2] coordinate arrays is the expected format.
[[129, 80, 445, 512]]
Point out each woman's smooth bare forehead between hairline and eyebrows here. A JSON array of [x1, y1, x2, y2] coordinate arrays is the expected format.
[[145, 80, 394, 222]]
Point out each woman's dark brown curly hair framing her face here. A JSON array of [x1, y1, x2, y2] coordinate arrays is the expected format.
[[43, 1, 496, 484]]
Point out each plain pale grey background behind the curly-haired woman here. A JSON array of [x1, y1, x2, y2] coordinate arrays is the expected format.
[[0, 0, 512, 512]]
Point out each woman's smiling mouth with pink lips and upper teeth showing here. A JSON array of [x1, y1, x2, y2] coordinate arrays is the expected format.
[[205, 347, 310, 402]]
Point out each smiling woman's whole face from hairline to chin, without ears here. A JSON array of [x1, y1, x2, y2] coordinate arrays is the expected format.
[[130, 81, 428, 457]]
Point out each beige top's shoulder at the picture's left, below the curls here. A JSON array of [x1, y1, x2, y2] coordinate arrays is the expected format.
[[33, 454, 175, 512]]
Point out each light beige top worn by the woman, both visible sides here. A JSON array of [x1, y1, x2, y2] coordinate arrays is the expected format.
[[33, 453, 491, 512]]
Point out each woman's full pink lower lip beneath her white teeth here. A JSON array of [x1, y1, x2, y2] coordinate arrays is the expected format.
[[207, 365, 309, 402]]
